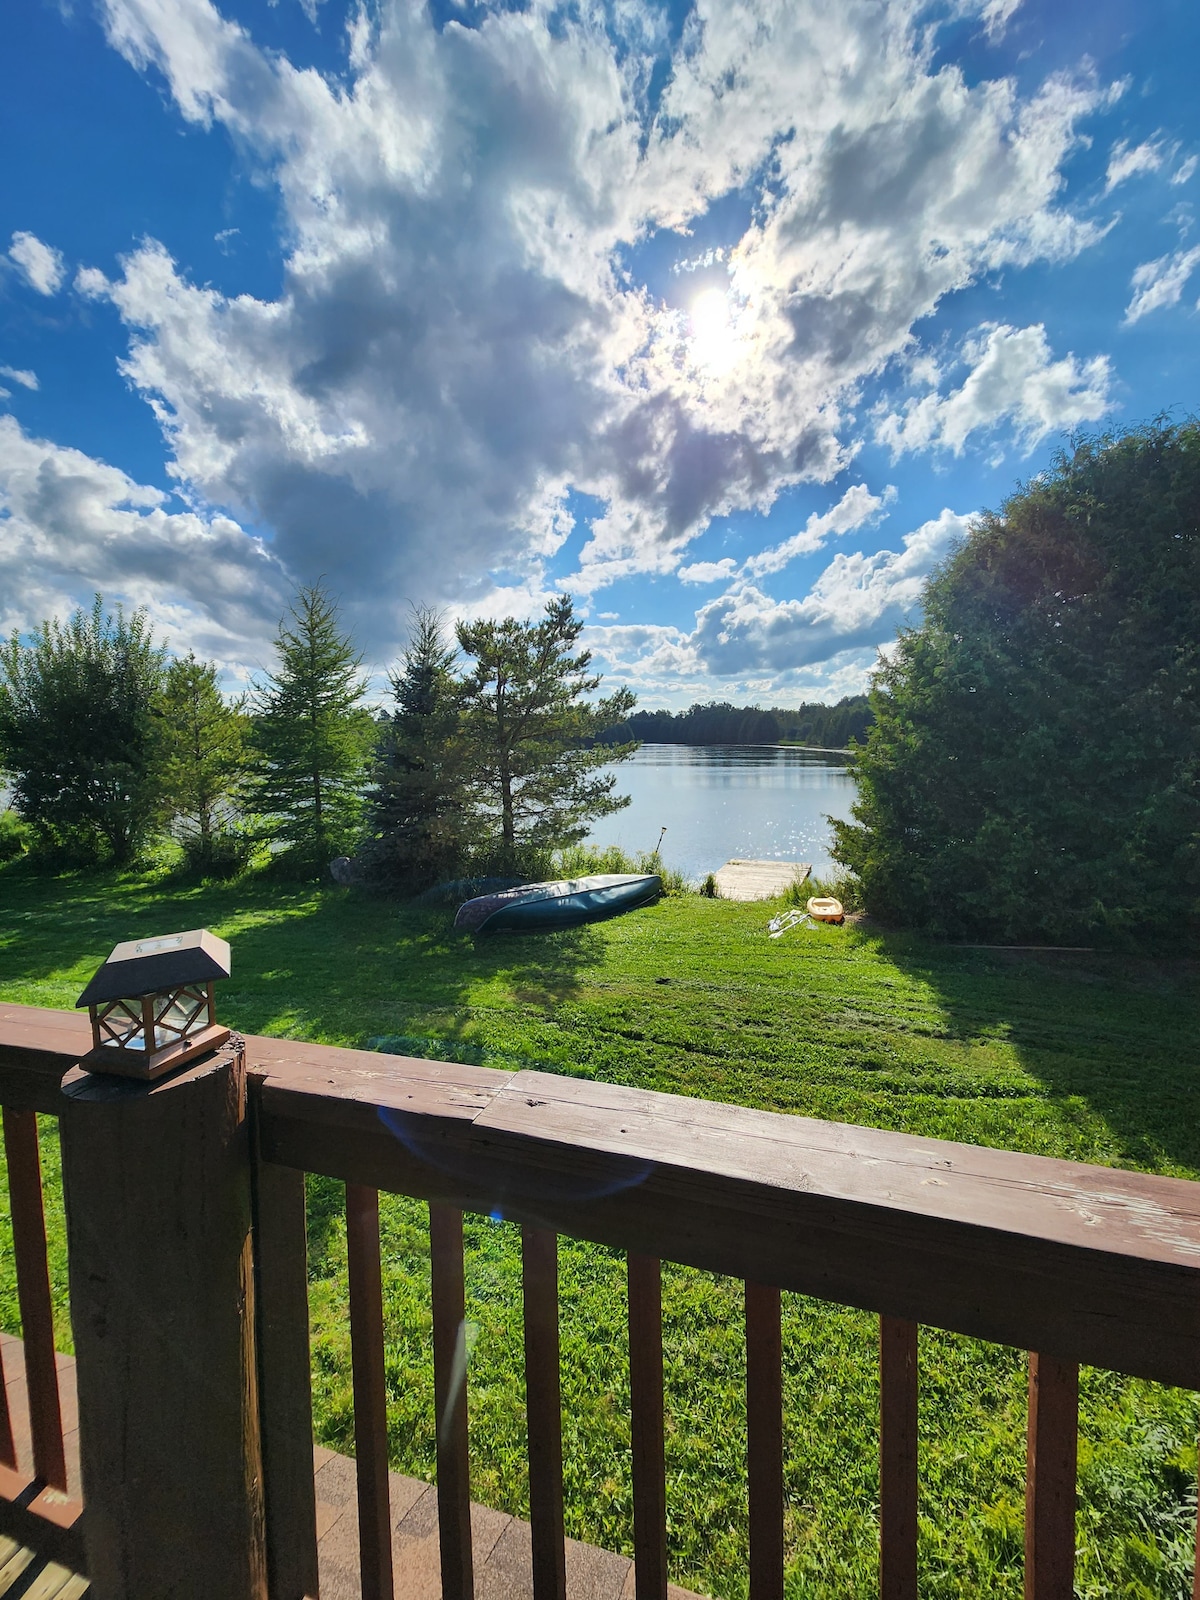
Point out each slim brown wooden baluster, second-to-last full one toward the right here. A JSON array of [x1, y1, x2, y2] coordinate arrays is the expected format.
[[878, 1317, 917, 1600]]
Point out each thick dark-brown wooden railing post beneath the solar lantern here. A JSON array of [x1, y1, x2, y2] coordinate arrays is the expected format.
[[61, 1046, 267, 1600]]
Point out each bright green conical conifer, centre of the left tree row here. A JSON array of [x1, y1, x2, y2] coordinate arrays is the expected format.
[[253, 584, 374, 877]]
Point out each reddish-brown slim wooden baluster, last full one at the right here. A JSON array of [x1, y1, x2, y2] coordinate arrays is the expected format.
[[1026, 1354, 1078, 1600]]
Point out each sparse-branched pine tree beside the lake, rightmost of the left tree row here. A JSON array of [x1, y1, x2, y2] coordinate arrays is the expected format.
[[458, 595, 637, 870]]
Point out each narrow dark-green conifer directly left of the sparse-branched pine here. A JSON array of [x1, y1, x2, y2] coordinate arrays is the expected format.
[[362, 608, 470, 891]]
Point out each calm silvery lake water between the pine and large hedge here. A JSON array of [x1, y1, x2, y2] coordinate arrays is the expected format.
[[589, 744, 854, 880]]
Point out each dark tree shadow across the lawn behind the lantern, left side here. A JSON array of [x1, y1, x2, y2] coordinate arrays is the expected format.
[[0, 864, 603, 1059]]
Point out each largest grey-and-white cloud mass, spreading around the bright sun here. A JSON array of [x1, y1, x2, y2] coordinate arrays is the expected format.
[[77, 0, 1110, 662]]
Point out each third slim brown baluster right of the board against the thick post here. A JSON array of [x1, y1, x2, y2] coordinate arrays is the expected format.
[[522, 1227, 566, 1600]]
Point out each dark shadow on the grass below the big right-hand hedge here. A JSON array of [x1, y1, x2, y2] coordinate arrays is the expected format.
[[864, 928, 1200, 1176]]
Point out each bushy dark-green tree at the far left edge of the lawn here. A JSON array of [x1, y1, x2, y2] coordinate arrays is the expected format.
[[0, 595, 165, 866]]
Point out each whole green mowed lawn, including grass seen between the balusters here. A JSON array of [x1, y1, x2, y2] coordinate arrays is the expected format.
[[0, 866, 1200, 1600]]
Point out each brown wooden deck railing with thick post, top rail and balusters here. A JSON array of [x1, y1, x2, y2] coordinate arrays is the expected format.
[[0, 1008, 1200, 1600]]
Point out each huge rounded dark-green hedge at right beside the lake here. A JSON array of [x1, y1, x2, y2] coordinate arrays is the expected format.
[[835, 421, 1200, 946]]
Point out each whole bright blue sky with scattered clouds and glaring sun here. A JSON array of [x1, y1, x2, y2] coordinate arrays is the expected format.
[[0, 0, 1200, 706]]
